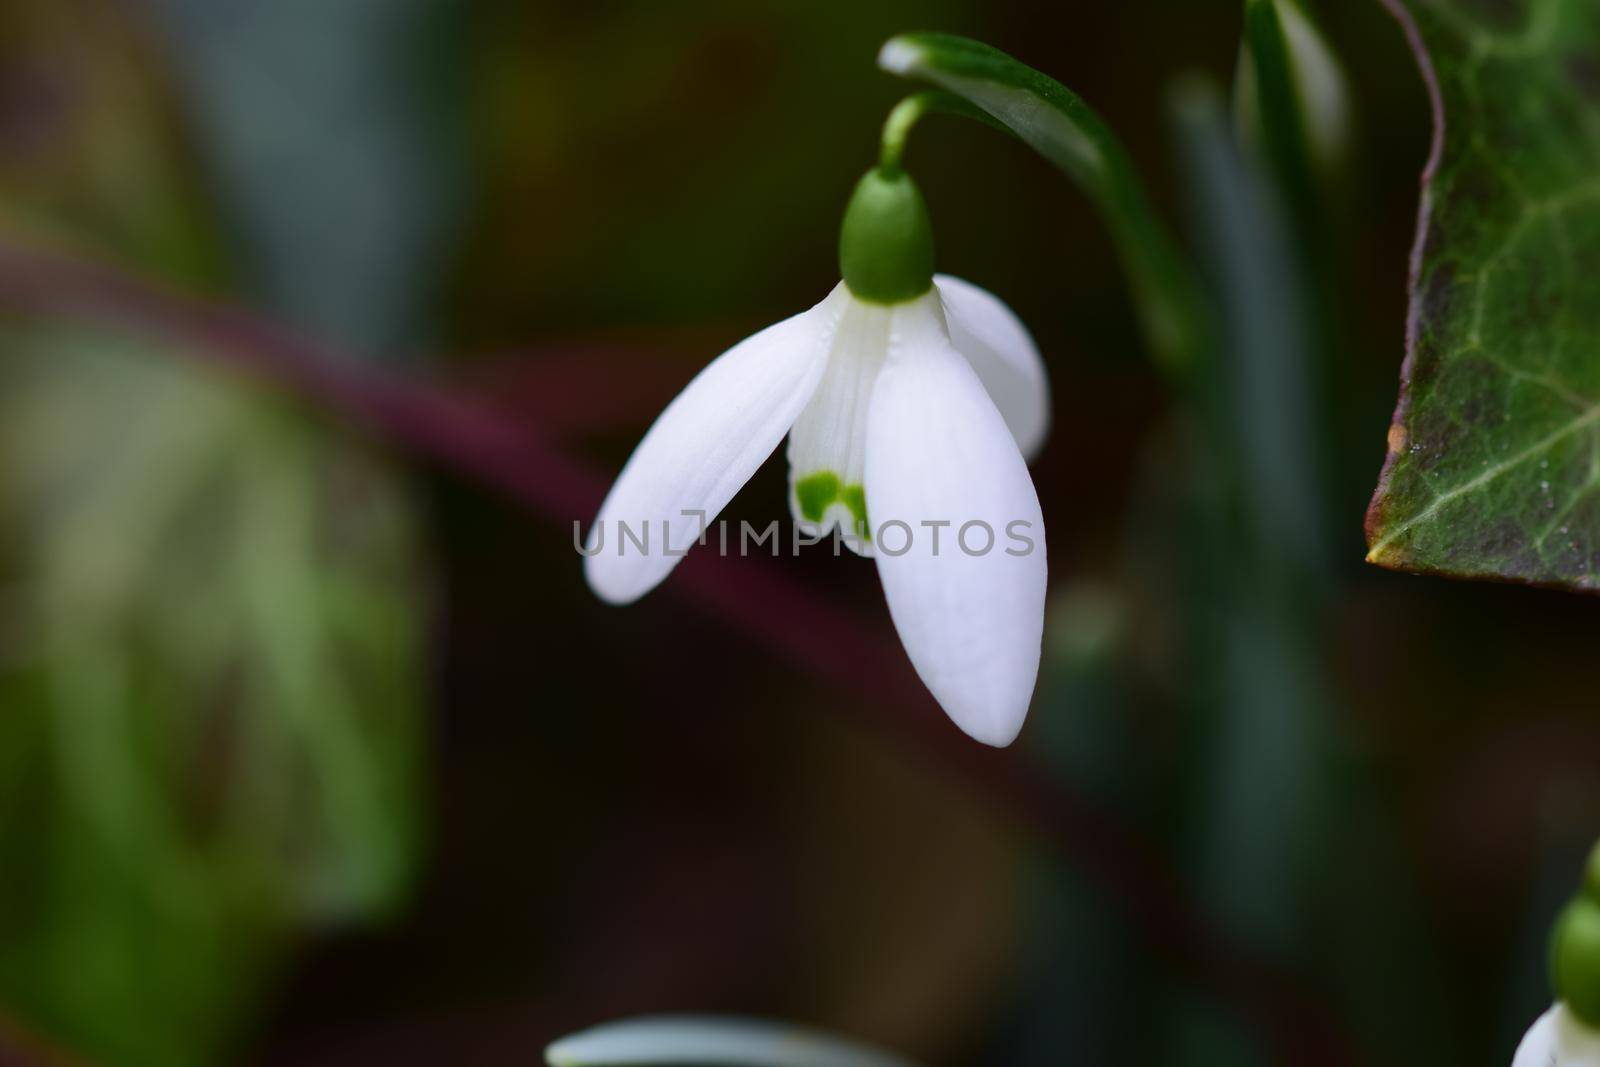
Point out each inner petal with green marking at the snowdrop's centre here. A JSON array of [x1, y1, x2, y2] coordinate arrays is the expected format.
[[789, 296, 902, 555]]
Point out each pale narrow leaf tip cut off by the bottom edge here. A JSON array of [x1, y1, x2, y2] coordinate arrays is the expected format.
[[544, 1016, 912, 1067]]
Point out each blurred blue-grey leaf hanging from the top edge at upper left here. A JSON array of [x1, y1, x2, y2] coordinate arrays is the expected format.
[[150, 0, 466, 355]]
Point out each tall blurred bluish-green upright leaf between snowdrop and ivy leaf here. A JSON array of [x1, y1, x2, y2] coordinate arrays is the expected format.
[[1176, 68, 1330, 979]]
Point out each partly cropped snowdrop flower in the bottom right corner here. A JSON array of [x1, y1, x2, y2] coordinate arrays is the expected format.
[[1512, 846, 1600, 1067]]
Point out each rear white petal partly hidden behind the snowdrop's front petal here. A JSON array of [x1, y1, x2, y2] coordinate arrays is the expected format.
[[933, 274, 1050, 459]]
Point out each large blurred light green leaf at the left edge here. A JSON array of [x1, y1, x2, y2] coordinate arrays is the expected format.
[[0, 323, 422, 1065]]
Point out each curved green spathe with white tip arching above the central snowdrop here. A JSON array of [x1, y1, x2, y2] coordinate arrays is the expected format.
[[878, 34, 1202, 379]]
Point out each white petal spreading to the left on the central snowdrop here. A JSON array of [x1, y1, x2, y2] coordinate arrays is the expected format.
[[584, 286, 848, 603]]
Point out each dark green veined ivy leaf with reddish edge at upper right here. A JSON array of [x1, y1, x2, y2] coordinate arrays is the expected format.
[[1366, 0, 1600, 590]]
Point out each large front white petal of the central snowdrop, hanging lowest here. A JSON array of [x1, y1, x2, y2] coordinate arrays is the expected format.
[[867, 292, 1046, 745]]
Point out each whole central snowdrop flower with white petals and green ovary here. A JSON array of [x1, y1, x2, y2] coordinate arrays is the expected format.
[[584, 166, 1050, 745]]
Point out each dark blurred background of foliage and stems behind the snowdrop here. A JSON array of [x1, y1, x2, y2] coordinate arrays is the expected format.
[[0, 0, 1600, 1067]]
